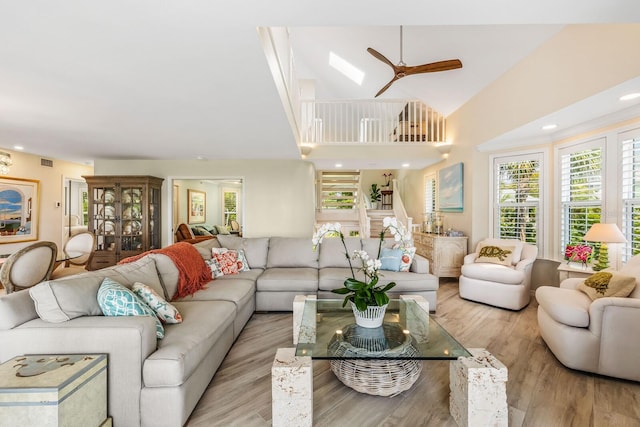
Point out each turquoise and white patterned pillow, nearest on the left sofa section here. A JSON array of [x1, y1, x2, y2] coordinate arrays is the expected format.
[[98, 277, 164, 339]]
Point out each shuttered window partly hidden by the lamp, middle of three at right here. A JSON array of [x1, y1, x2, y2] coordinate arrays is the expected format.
[[559, 139, 604, 257]]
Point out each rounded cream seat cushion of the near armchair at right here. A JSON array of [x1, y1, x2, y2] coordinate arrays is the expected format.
[[536, 286, 591, 328]]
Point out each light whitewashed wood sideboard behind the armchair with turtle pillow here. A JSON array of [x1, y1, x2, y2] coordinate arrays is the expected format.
[[413, 233, 467, 277]]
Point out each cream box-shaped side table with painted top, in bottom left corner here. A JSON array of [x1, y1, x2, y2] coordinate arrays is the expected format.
[[0, 354, 111, 427]]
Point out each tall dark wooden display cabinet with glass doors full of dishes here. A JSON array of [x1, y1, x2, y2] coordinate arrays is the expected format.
[[84, 175, 163, 270]]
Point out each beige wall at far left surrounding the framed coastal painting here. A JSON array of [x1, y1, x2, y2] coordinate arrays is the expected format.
[[0, 148, 93, 254]]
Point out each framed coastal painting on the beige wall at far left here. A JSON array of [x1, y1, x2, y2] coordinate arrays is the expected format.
[[0, 178, 40, 244]]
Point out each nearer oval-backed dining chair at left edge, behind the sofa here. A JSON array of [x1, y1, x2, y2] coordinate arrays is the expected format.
[[0, 241, 58, 294]]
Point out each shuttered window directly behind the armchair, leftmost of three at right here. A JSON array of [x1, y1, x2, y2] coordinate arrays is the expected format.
[[493, 153, 543, 247]]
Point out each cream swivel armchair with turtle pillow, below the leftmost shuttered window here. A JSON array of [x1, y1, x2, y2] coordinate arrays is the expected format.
[[460, 239, 538, 310]]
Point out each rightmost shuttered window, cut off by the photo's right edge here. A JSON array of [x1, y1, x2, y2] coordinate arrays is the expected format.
[[619, 129, 640, 262]]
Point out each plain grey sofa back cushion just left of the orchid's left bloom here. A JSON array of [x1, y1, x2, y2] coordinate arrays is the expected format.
[[267, 237, 318, 268]]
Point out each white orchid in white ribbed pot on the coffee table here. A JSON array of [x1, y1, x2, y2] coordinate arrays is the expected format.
[[313, 218, 409, 328]]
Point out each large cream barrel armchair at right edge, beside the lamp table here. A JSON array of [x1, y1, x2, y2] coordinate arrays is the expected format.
[[536, 255, 640, 381]]
